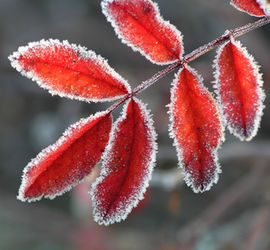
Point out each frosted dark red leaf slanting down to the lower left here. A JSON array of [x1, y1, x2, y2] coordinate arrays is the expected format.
[[18, 112, 112, 202]]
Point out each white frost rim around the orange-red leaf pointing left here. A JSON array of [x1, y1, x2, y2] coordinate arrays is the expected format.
[[8, 39, 131, 102]]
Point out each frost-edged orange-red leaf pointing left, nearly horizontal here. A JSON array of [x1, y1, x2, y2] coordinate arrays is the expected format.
[[9, 39, 130, 102]]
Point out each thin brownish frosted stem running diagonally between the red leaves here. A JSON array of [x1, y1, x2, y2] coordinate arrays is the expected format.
[[108, 17, 270, 113]]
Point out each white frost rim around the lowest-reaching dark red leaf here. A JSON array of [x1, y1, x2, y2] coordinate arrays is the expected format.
[[90, 98, 157, 225]]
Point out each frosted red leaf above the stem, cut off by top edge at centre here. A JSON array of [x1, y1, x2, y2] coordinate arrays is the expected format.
[[102, 0, 183, 65]]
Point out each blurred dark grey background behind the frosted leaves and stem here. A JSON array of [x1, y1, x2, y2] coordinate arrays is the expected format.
[[0, 0, 270, 250]]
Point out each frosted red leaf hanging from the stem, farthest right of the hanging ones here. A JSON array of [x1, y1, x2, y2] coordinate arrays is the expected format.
[[216, 40, 264, 141]]
